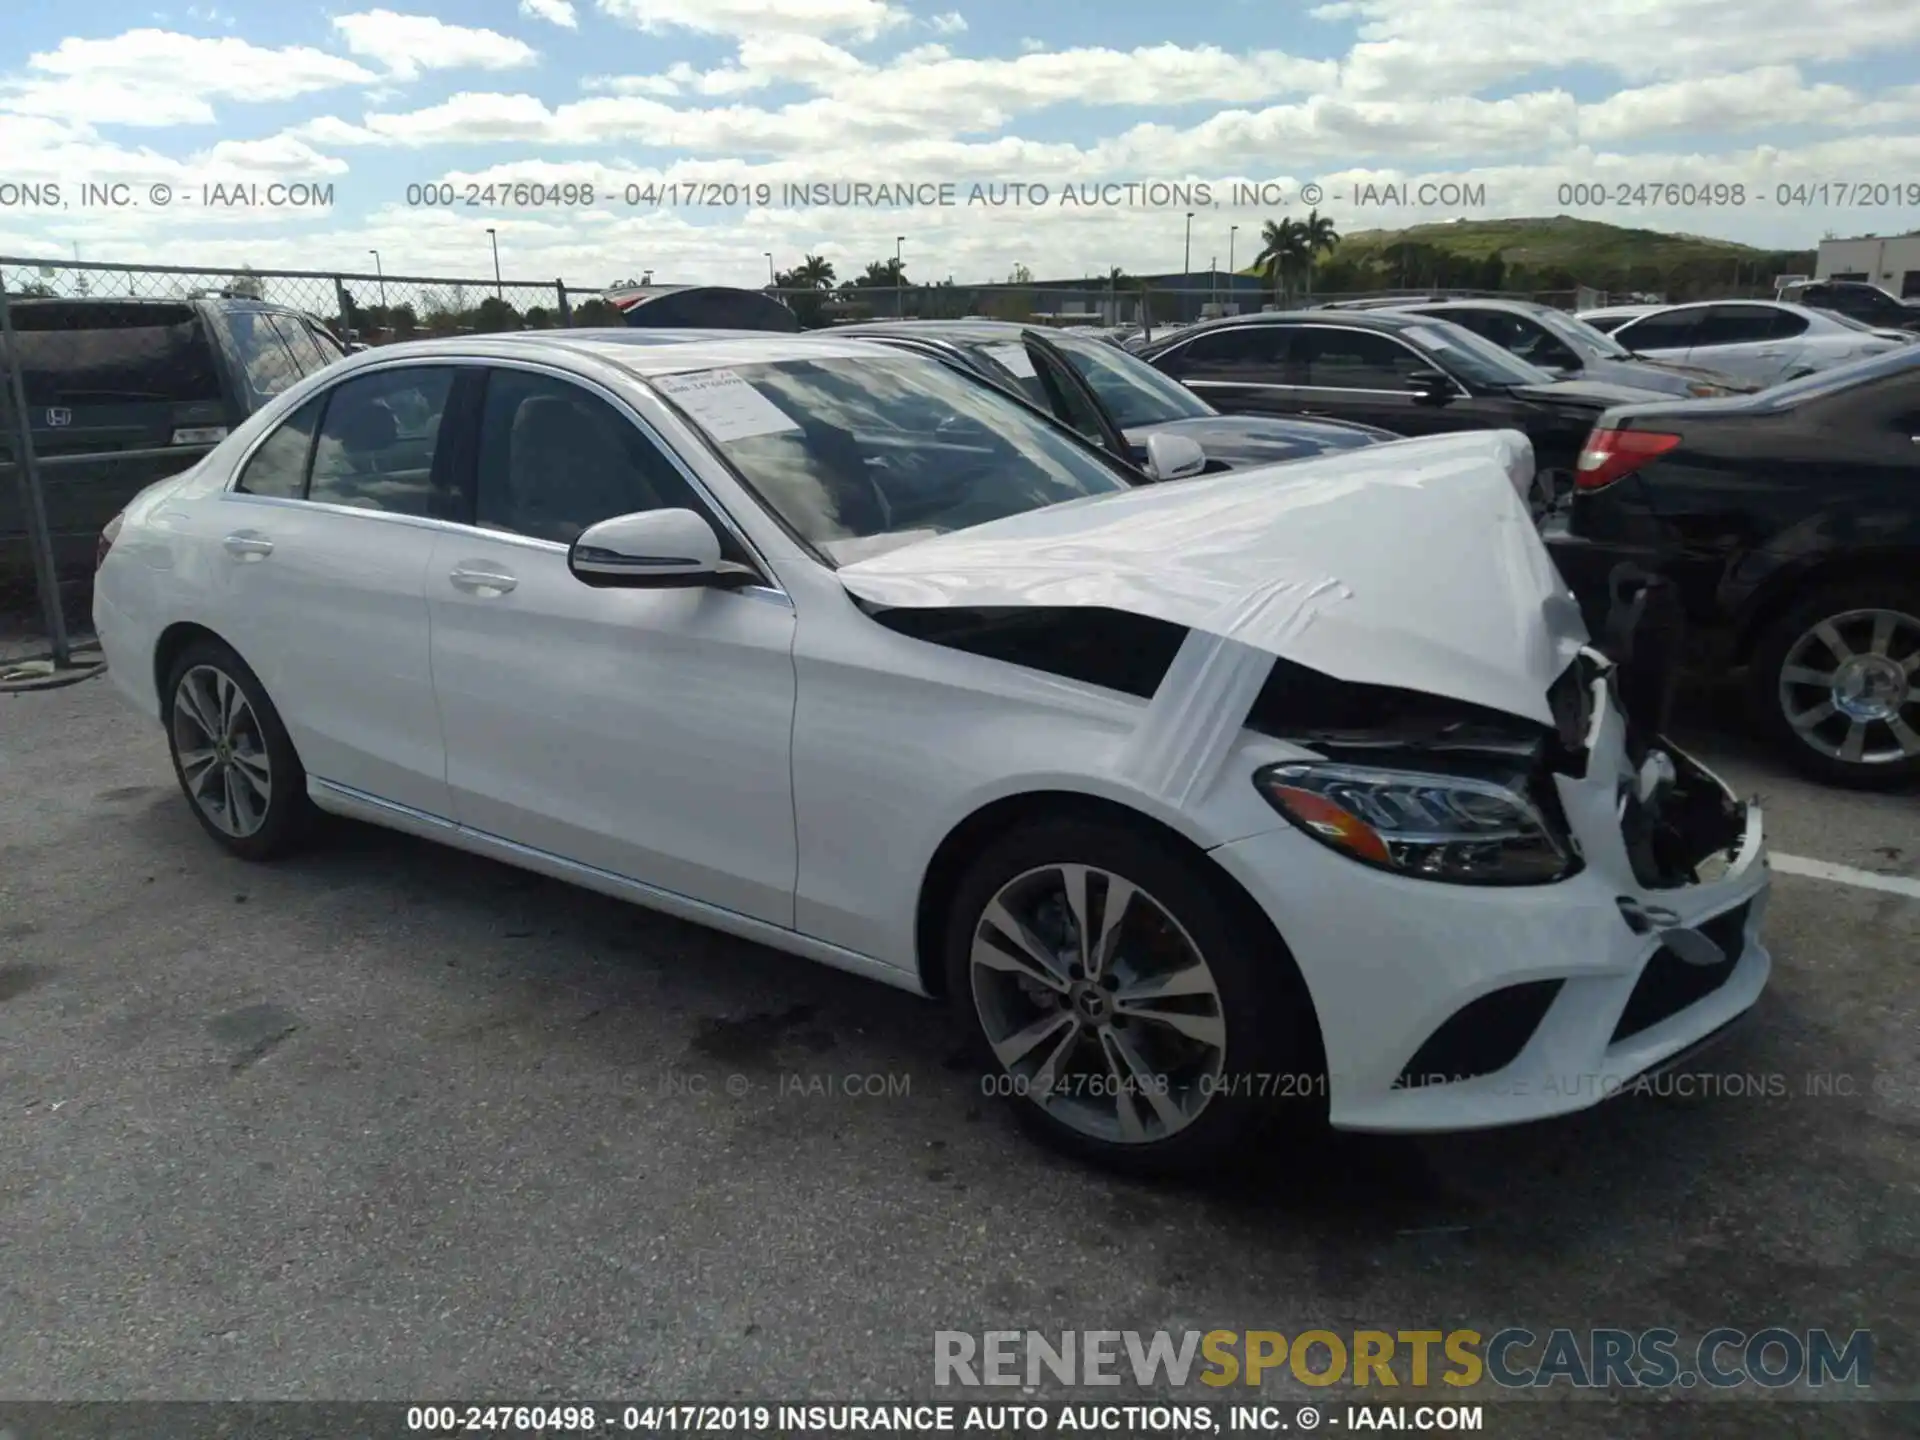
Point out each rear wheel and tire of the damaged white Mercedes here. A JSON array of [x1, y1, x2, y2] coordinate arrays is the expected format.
[[161, 639, 313, 860]]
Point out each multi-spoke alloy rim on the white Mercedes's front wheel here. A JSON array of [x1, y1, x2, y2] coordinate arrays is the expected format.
[[968, 864, 1227, 1144]]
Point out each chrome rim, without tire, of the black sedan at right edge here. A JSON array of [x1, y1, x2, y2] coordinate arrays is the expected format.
[[1780, 611, 1920, 764]]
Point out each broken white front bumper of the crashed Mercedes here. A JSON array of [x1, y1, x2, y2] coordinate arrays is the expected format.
[[1213, 660, 1772, 1131]]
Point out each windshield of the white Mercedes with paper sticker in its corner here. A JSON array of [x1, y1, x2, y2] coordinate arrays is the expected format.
[[653, 355, 1131, 564]]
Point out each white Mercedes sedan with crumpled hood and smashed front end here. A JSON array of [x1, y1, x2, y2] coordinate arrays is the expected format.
[[94, 332, 1770, 1167]]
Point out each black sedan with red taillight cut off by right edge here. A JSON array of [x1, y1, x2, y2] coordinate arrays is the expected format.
[[1548, 349, 1920, 785]]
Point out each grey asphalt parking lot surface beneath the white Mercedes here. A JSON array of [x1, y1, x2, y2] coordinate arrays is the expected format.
[[0, 680, 1920, 1440]]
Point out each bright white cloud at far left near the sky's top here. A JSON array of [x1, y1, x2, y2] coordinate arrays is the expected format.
[[0, 29, 374, 126]]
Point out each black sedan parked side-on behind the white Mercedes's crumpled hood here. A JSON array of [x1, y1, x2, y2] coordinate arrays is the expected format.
[[1140, 309, 1661, 488]]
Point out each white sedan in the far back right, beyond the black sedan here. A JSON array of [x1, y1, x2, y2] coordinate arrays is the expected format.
[[1582, 300, 1914, 386]]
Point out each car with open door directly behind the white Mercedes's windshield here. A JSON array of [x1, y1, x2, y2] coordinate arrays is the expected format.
[[833, 321, 1400, 472]]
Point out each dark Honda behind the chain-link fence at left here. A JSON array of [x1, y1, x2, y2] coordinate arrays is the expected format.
[[0, 296, 346, 589]]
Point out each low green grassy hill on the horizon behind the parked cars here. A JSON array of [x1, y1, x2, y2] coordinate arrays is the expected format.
[[1244, 215, 1814, 300]]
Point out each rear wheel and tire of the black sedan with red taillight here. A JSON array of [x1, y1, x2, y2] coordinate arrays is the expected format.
[[1753, 578, 1920, 789]]
